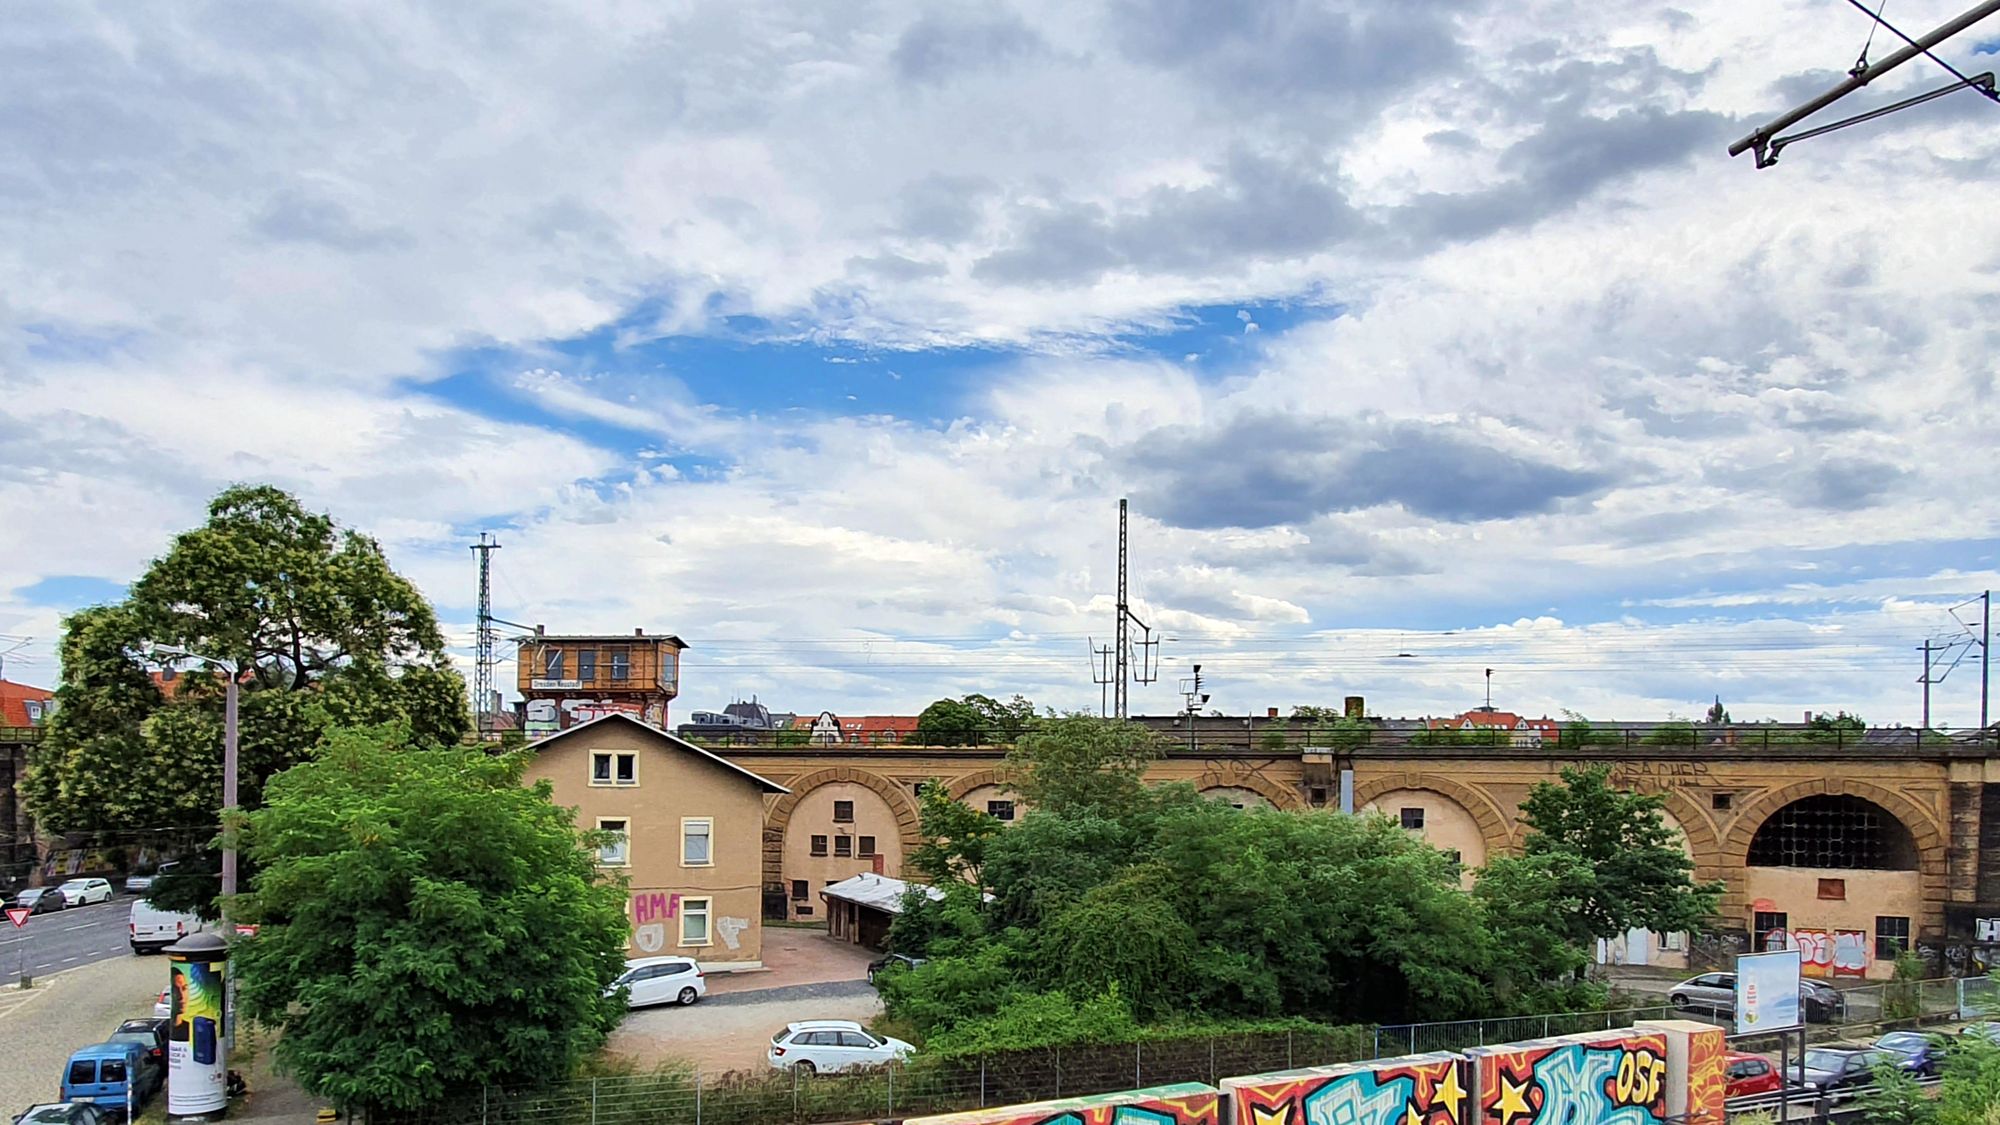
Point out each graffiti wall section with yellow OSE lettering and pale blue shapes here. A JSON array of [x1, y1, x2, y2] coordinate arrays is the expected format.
[[1466, 1031, 1668, 1125]]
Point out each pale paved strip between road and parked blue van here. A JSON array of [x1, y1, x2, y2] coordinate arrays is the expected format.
[[0, 953, 166, 1121]]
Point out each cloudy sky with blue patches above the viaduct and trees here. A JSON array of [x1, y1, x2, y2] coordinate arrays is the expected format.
[[0, 0, 2000, 727]]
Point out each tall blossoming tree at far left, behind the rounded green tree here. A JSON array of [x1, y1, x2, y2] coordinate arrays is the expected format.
[[24, 486, 468, 848]]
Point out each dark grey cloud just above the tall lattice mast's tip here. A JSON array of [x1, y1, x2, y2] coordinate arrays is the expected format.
[[1122, 414, 1614, 528]]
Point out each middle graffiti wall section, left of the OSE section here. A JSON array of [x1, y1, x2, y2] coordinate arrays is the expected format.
[[1222, 1055, 1472, 1125]]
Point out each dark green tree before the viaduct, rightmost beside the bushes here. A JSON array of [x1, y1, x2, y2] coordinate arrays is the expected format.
[[1520, 765, 1722, 947]]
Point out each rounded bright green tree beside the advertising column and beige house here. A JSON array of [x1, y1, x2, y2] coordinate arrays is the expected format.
[[232, 725, 628, 1111]]
